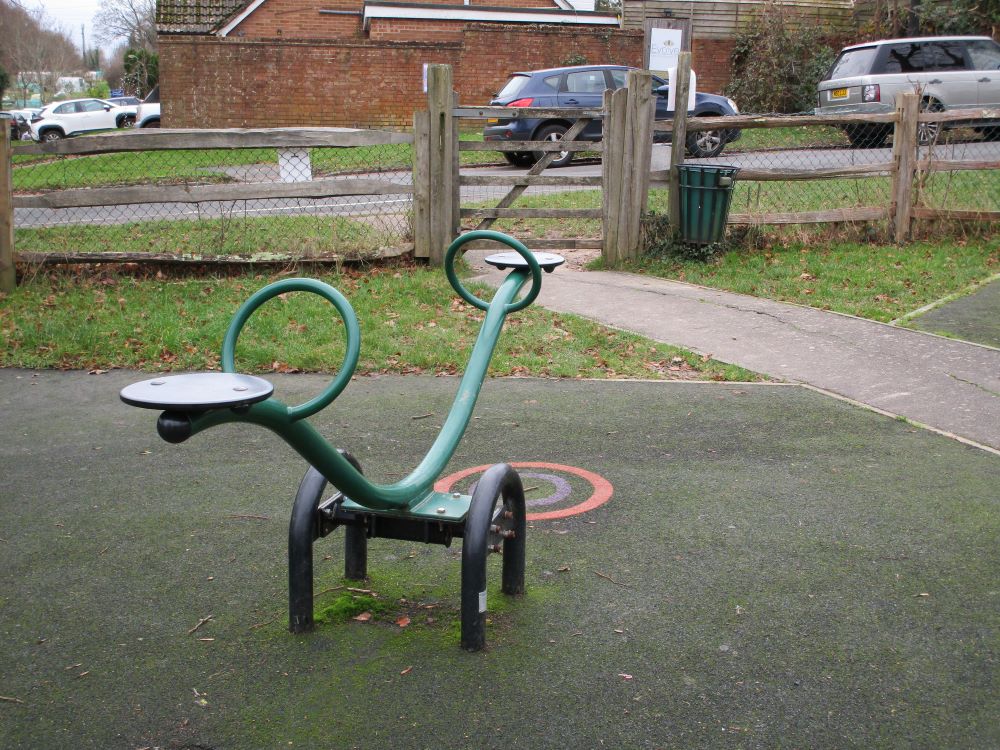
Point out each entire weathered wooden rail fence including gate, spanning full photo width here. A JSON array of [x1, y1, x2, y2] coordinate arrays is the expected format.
[[0, 67, 1000, 291]]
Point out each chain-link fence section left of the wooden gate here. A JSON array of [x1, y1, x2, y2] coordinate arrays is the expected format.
[[12, 138, 413, 261]]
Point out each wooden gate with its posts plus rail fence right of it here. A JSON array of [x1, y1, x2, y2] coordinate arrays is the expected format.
[[415, 61, 1000, 263]]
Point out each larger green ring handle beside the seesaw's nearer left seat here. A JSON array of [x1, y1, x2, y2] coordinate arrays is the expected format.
[[222, 279, 361, 421]]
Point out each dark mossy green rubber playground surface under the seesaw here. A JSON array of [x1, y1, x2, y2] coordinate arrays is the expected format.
[[0, 370, 1000, 749]]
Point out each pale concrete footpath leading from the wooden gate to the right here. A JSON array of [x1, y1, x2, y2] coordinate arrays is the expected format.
[[470, 258, 1000, 450]]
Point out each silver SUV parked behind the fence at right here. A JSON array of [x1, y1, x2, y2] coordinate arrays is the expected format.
[[816, 36, 1000, 148]]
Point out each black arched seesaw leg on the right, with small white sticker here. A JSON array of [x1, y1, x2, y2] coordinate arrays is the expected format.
[[462, 464, 525, 651]]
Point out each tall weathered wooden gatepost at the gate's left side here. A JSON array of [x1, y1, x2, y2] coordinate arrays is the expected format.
[[427, 65, 458, 266]]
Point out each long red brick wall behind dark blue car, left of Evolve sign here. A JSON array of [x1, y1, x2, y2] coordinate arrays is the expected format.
[[159, 24, 643, 128]]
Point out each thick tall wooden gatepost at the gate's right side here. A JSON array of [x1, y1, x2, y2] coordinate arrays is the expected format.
[[622, 70, 654, 258]]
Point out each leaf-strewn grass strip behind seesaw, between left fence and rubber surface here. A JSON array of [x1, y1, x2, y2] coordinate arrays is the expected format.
[[0, 268, 758, 381]]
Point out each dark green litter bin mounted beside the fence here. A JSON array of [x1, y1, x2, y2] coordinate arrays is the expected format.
[[677, 164, 739, 245]]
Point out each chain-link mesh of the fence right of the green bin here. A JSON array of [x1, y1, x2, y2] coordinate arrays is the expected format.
[[649, 108, 1000, 232]]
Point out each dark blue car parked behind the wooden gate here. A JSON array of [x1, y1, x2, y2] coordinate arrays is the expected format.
[[483, 65, 740, 167]]
